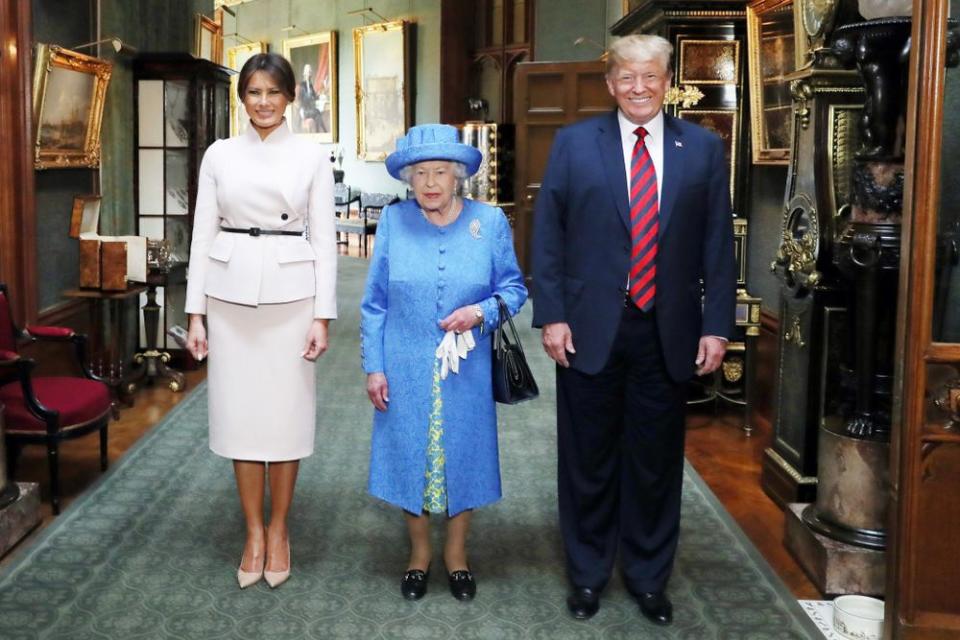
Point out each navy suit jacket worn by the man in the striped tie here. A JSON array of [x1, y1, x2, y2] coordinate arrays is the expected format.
[[532, 111, 736, 382]]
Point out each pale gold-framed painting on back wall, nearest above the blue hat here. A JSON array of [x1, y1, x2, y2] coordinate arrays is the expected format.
[[353, 20, 411, 161]]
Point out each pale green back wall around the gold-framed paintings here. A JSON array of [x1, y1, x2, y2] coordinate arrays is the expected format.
[[224, 0, 440, 194]]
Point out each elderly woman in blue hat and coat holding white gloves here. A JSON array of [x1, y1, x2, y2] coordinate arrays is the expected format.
[[360, 124, 527, 600]]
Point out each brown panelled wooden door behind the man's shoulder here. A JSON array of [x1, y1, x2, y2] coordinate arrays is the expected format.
[[513, 60, 616, 277]]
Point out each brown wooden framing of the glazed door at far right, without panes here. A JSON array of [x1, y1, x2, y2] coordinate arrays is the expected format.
[[884, 0, 960, 640]]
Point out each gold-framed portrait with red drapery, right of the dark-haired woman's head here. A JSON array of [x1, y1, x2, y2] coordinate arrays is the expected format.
[[283, 31, 338, 142]]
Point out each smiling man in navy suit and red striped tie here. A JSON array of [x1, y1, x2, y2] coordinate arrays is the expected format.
[[533, 35, 736, 624]]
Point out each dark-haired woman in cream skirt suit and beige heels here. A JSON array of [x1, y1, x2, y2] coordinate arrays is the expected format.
[[186, 53, 337, 588]]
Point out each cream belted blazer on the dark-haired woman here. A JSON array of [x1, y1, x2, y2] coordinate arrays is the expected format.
[[185, 123, 337, 319]]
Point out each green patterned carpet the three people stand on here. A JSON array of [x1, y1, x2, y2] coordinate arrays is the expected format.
[[0, 258, 818, 640]]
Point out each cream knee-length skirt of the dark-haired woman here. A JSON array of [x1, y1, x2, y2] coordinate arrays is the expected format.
[[207, 298, 317, 462]]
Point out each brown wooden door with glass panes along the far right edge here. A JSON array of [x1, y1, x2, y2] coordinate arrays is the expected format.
[[885, 0, 960, 640]]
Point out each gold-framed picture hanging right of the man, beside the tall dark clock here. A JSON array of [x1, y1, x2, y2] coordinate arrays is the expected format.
[[747, 0, 796, 164]]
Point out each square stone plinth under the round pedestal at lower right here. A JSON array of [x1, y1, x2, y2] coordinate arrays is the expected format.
[[784, 503, 886, 596]]
